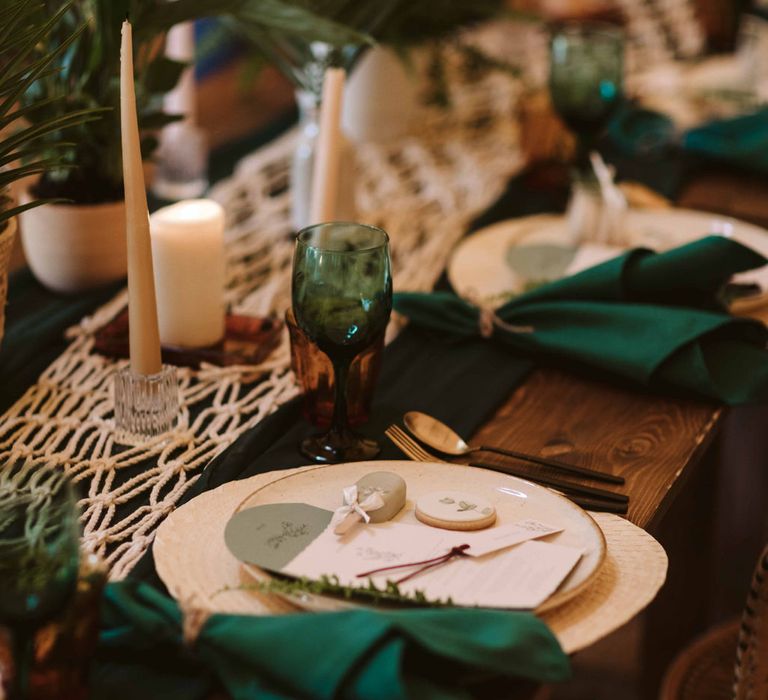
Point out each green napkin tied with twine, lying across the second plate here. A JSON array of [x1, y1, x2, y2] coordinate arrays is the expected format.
[[394, 236, 768, 404]]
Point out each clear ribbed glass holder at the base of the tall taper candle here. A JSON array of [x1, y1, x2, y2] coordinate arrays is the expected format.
[[115, 365, 179, 445]]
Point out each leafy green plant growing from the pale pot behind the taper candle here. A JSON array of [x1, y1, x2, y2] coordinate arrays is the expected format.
[[22, 0, 365, 204]]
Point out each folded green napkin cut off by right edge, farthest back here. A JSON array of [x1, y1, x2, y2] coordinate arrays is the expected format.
[[683, 109, 768, 172]]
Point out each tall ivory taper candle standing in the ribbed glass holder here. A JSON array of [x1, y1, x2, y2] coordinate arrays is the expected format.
[[120, 20, 161, 375]]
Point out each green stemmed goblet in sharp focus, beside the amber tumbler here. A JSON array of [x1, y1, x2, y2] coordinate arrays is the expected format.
[[292, 222, 392, 463]]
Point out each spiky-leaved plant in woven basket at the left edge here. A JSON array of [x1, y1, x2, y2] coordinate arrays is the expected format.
[[0, 0, 94, 340]]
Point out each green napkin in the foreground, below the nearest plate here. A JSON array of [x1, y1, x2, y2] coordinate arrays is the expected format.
[[91, 580, 570, 700]]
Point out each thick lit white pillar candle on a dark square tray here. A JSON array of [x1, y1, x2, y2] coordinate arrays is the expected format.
[[150, 199, 225, 348]]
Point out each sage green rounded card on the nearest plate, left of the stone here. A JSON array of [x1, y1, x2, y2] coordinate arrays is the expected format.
[[224, 503, 333, 572]]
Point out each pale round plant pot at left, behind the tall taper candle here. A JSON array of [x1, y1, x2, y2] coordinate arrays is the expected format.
[[21, 193, 127, 293]]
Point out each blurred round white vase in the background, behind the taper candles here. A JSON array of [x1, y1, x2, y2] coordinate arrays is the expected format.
[[341, 46, 428, 143]]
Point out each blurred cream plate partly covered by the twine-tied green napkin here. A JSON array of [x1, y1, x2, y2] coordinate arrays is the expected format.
[[448, 209, 768, 310]]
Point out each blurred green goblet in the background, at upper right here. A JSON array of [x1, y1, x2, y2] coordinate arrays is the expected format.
[[549, 23, 624, 174]]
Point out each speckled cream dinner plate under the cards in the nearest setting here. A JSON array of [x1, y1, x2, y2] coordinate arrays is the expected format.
[[231, 461, 606, 612]]
